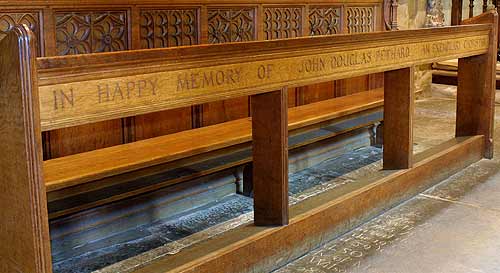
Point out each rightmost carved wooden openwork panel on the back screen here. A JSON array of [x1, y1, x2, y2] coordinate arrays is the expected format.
[[347, 7, 375, 33]]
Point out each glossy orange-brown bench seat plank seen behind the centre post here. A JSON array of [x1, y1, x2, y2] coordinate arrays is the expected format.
[[44, 90, 384, 192]]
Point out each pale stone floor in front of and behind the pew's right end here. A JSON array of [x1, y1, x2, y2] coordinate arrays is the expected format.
[[275, 95, 500, 273]]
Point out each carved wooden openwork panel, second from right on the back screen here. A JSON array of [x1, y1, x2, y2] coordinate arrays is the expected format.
[[309, 7, 341, 36]]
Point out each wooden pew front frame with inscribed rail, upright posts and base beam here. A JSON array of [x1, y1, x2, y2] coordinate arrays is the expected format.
[[0, 13, 498, 273]]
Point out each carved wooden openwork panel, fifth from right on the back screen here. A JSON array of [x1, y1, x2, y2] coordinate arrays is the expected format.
[[141, 9, 199, 48]]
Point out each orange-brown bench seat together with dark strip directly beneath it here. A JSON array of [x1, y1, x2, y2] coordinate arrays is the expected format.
[[44, 89, 383, 219]]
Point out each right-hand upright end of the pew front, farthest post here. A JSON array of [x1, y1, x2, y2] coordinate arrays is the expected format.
[[456, 12, 498, 158]]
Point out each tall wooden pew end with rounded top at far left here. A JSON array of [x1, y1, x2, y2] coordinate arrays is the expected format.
[[0, 26, 52, 273]]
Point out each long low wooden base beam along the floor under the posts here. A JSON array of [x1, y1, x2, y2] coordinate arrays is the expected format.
[[134, 136, 484, 273]]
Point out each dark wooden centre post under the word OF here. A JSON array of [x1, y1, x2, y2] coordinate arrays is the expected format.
[[251, 89, 288, 226]]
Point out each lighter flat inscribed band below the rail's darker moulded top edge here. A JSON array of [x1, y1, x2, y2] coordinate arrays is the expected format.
[[40, 34, 489, 129]]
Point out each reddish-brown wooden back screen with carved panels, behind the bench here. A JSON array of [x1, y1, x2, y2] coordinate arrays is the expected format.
[[0, 0, 384, 159]]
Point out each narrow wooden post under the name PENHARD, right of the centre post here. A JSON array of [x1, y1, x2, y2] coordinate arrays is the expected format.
[[383, 67, 415, 170]]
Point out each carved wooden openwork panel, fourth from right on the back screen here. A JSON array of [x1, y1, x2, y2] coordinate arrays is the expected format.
[[208, 8, 255, 44]]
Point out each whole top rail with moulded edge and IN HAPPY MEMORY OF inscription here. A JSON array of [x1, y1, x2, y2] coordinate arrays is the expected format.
[[37, 25, 492, 131]]
